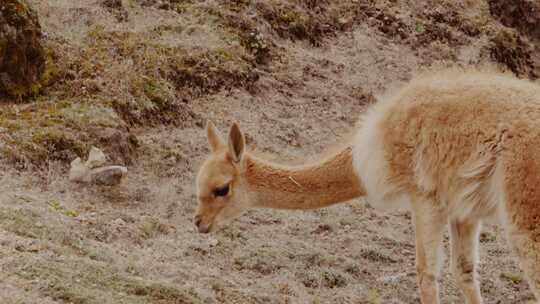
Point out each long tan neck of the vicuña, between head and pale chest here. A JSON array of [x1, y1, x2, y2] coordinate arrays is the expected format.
[[245, 147, 365, 209]]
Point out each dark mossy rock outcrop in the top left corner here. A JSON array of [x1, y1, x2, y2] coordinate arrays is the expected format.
[[0, 0, 46, 97]]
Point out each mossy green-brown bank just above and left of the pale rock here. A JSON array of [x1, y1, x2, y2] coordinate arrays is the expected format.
[[0, 101, 121, 166]]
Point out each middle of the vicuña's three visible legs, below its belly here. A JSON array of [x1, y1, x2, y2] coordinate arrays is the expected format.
[[450, 220, 482, 304]]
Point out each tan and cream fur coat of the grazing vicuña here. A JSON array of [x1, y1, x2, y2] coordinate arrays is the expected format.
[[197, 71, 540, 304]]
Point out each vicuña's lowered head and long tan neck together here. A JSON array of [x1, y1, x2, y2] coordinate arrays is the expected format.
[[194, 122, 362, 233]]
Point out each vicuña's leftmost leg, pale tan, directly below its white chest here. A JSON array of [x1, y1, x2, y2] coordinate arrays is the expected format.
[[413, 200, 446, 304]]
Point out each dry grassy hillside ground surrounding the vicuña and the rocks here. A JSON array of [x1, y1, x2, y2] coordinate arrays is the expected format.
[[0, 0, 540, 304]]
